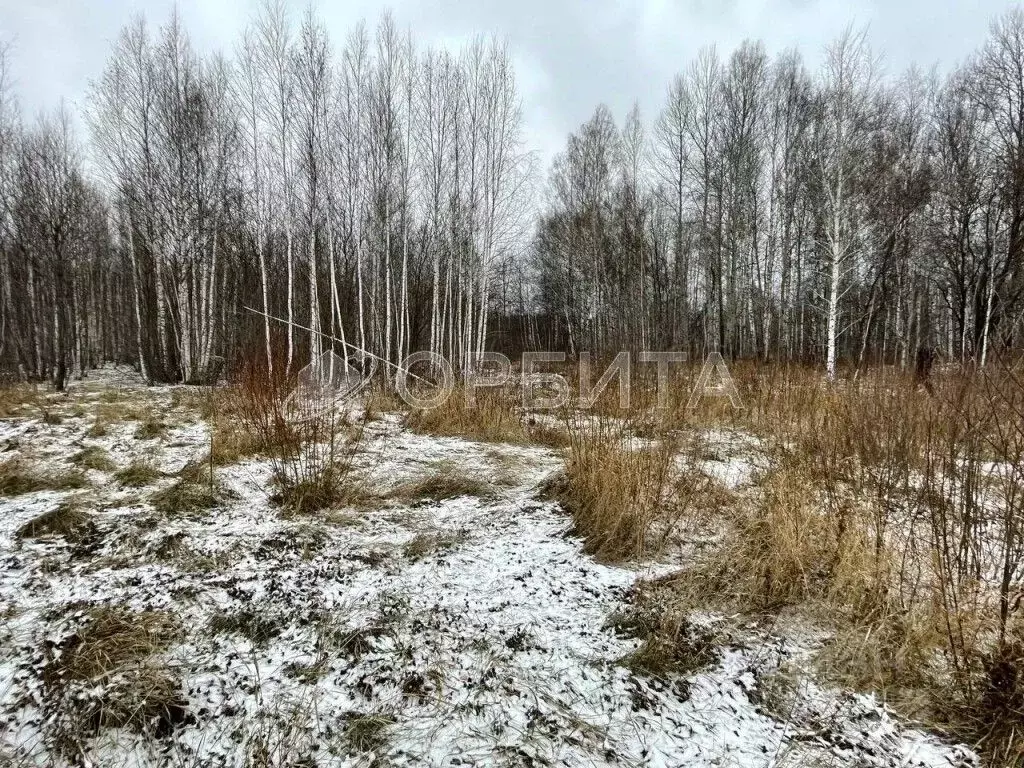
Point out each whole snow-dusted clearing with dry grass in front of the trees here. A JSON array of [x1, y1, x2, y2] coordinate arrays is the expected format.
[[0, 368, 1024, 766]]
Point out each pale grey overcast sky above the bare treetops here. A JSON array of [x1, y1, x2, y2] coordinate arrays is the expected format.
[[0, 0, 1013, 163]]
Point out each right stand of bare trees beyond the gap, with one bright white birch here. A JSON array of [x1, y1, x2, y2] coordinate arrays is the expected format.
[[535, 18, 1024, 373]]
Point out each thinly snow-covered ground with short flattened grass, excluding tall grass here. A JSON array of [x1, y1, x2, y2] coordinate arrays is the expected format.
[[0, 370, 976, 768]]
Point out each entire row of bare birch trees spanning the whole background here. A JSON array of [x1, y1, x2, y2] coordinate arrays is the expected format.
[[0, 2, 1024, 386]]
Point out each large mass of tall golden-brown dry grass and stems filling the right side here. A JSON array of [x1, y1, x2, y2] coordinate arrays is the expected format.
[[622, 364, 1024, 765]]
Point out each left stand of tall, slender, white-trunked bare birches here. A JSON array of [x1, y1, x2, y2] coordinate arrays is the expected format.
[[0, 3, 529, 385]]
